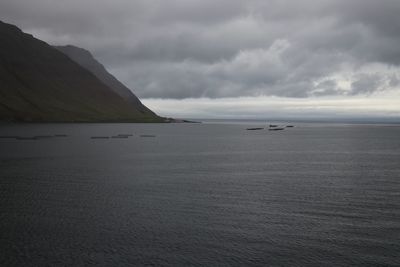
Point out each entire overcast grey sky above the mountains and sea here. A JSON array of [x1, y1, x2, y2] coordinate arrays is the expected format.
[[0, 0, 400, 120]]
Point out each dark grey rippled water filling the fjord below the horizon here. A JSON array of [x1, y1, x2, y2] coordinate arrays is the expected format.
[[0, 124, 400, 266]]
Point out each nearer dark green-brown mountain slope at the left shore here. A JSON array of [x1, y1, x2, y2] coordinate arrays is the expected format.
[[0, 21, 164, 122]]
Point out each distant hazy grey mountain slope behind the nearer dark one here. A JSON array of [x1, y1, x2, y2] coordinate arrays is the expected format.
[[54, 45, 153, 113]]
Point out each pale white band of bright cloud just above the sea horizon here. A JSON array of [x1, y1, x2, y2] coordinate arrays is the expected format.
[[143, 90, 400, 120]]
